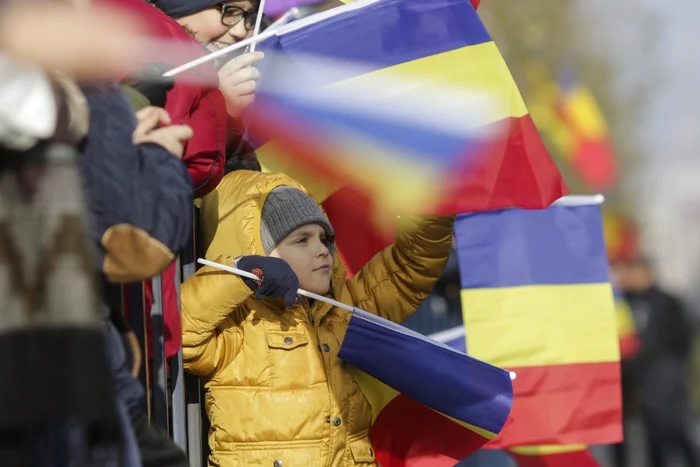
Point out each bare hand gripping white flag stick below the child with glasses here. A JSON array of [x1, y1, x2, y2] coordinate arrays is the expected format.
[[219, 52, 265, 118]]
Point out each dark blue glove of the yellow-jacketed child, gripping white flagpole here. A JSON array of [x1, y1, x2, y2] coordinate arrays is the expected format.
[[236, 256, 299, 307]]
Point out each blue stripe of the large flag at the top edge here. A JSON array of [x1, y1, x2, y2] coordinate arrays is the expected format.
[[259, 0, 491, 87]]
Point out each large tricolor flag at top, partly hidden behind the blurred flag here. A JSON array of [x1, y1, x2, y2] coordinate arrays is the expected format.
[[257, 0, 566, 271]]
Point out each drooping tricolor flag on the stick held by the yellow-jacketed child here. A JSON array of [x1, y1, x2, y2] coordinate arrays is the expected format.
[[338, 309, 513, 467]]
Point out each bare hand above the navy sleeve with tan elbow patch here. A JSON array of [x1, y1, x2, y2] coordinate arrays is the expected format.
[[132, 107, 194, 158]]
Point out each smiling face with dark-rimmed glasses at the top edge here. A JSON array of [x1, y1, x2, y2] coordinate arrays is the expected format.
[[177, 0, 256, 52]]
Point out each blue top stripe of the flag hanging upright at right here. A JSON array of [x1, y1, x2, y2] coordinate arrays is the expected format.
[[455, 205, 609, 289]]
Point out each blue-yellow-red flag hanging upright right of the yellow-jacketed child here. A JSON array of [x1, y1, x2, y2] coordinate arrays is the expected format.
[[455, 197, 622, 448]]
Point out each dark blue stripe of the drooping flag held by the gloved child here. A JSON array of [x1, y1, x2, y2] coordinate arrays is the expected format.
[[338, 309, 513, 433]]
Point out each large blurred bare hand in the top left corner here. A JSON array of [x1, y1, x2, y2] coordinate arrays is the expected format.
[[0, 0, 145, 80]]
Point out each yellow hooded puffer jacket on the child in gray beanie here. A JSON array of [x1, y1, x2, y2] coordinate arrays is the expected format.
[[182, 171, 454, 467]]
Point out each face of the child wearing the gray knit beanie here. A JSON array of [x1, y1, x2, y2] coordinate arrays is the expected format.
[[270, 224, 333, 295]]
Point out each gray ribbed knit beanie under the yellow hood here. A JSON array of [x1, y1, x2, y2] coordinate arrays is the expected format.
[[260, 186, 334, 255]]
